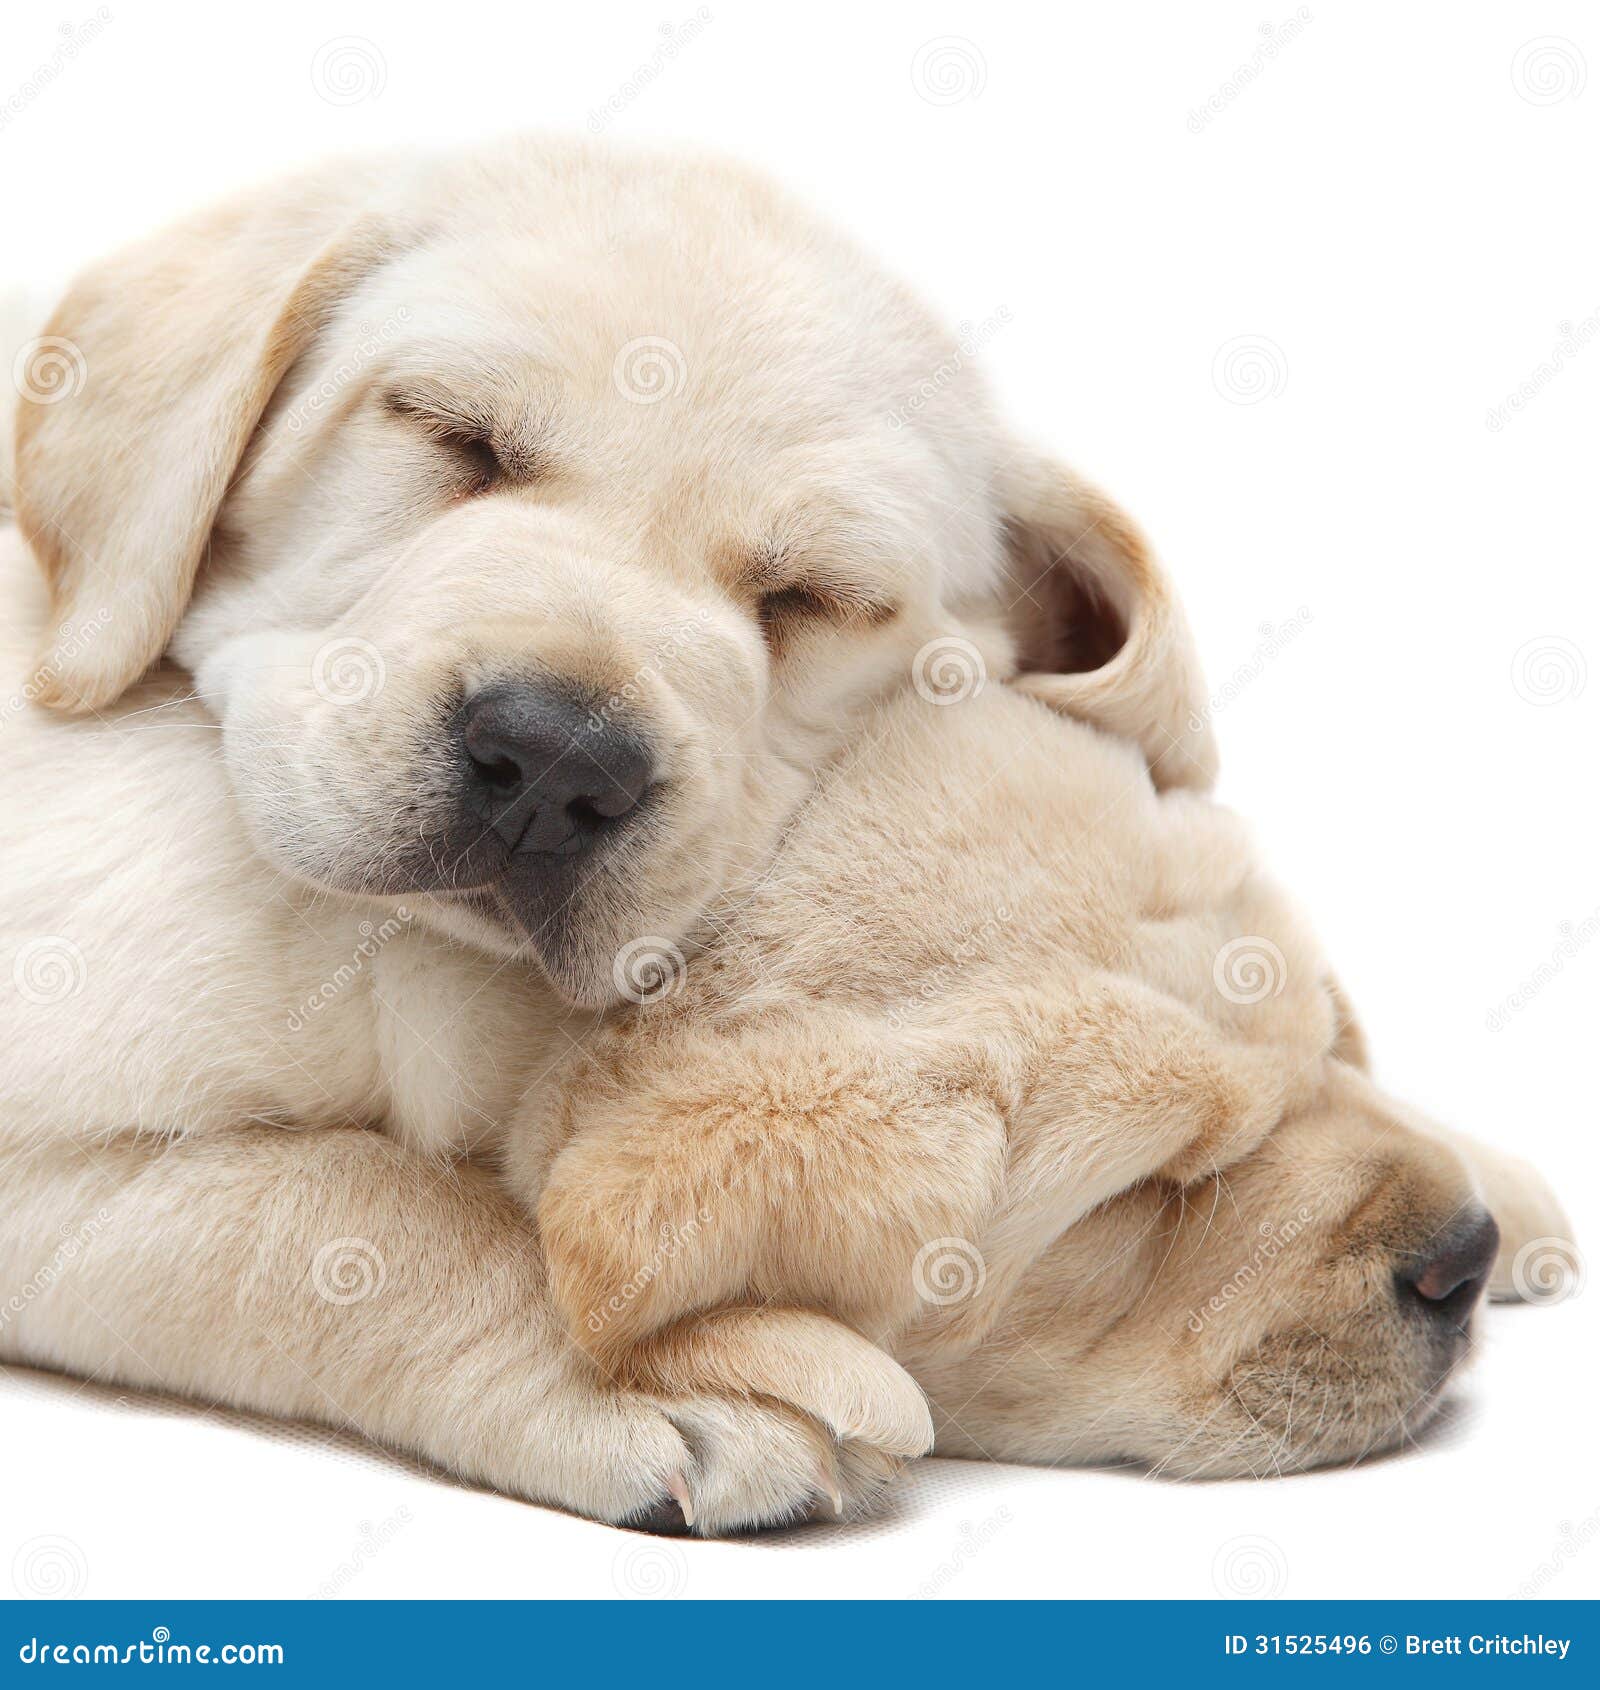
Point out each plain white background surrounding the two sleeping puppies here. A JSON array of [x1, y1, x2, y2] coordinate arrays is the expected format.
[[0, 0, 1600, 1602]]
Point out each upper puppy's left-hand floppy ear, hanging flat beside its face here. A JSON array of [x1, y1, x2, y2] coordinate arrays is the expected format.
[[15, 166, 400, 710]]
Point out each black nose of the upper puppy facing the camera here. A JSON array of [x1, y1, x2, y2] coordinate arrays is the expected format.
[[458, 684, 654, 857]]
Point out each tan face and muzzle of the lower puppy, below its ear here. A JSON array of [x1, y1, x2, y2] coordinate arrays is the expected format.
[[919, 1063, 1497, 1477]]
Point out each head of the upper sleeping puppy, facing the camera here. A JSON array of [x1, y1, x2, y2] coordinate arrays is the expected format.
[[17, 142, 1210, 1002]]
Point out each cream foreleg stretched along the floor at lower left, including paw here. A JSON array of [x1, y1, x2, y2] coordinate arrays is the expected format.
[[0, 1129, 851, 1529]]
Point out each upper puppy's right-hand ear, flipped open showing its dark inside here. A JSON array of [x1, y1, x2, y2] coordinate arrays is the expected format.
[[999, 455, 1216, 789]]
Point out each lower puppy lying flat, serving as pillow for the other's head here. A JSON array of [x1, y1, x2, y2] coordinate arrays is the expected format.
[[0, 503, 1563, 1531]]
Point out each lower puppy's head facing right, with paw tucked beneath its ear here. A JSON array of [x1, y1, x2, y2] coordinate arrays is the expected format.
[[509, 638, 1574, 1518]]
